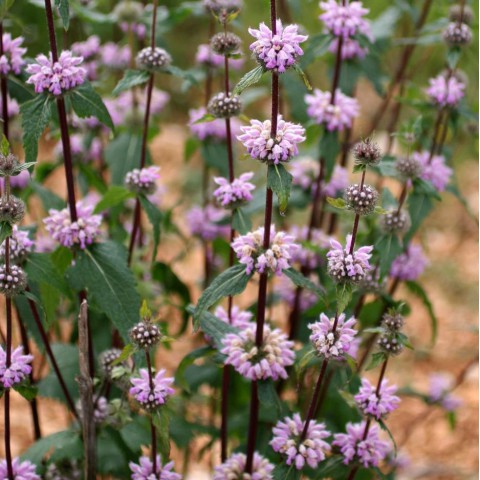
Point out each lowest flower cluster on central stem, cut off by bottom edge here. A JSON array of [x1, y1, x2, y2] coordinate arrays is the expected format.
[[213, 452, 274, 480]]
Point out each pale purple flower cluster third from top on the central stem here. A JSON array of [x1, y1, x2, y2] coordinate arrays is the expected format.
[[232, 225, 299, 276]]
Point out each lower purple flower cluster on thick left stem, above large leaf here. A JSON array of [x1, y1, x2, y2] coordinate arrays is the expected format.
[[43, 201, 102, 249]]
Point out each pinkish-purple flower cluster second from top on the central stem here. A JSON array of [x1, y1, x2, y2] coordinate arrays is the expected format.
[[237, 115, 306, 165]]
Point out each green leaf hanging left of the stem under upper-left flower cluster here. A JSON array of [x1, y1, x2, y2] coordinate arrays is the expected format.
[[20, 94, 53, 162]]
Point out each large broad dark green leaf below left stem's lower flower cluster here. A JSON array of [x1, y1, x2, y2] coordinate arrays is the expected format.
[[66, 241, 140, 342]]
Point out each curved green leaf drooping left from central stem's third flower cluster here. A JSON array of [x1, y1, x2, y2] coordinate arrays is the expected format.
[[193, 264, 253, 331]]
